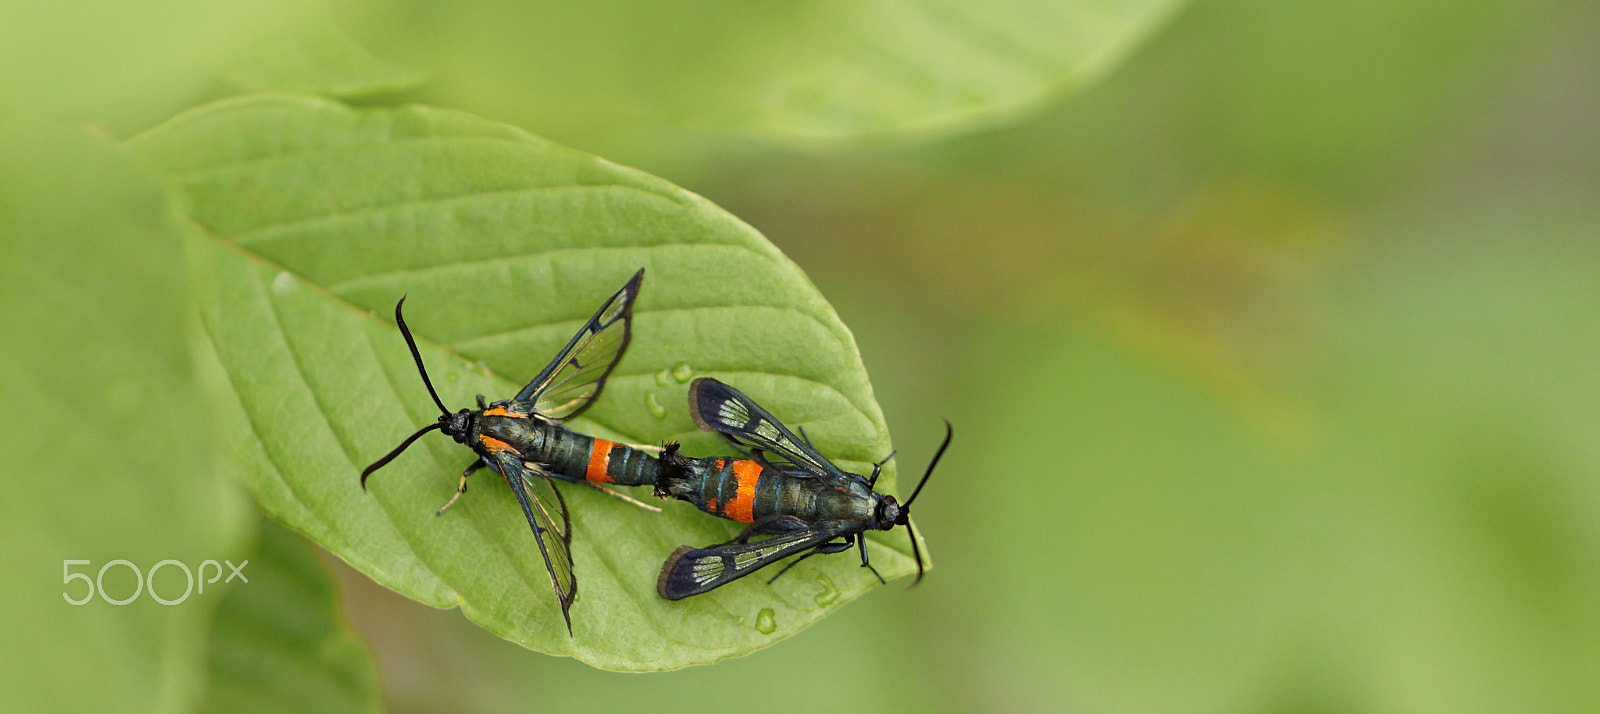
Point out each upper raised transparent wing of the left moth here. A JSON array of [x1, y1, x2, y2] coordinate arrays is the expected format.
[[510, 267, 645, 419]]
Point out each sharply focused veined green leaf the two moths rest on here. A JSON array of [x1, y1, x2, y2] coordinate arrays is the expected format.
[[131, 98, 915, 671]]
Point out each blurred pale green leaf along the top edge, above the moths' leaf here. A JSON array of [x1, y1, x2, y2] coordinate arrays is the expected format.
[[347, 0, 1182, 144]]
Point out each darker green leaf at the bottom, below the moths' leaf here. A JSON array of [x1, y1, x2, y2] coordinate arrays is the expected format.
[[200, 519, 381, 714]]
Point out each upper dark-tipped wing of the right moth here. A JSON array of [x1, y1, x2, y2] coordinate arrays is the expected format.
[[690, 376, 859, 480]]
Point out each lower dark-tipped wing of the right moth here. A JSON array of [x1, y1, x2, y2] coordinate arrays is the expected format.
[[656, 520, 846, 600]]
